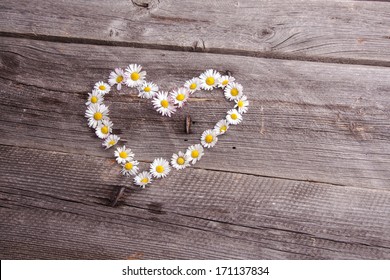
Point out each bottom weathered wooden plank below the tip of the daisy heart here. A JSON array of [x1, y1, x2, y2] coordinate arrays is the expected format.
[[0, 145, 390, 259]]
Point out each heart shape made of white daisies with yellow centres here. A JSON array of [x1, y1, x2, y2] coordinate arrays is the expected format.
[[85, 64, 249, 188]]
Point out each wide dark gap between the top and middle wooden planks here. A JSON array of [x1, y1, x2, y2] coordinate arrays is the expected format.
[[0, 31, 390, 67]]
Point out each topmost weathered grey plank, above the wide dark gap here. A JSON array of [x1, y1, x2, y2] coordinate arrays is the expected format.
[[0, 0, 390, 66]]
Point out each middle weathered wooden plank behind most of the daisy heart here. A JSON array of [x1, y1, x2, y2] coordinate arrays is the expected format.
[[0, 38, 390, 191]]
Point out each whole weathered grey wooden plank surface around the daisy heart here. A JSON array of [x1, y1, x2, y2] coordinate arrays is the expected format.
[[0, 0, 390, 259]]
